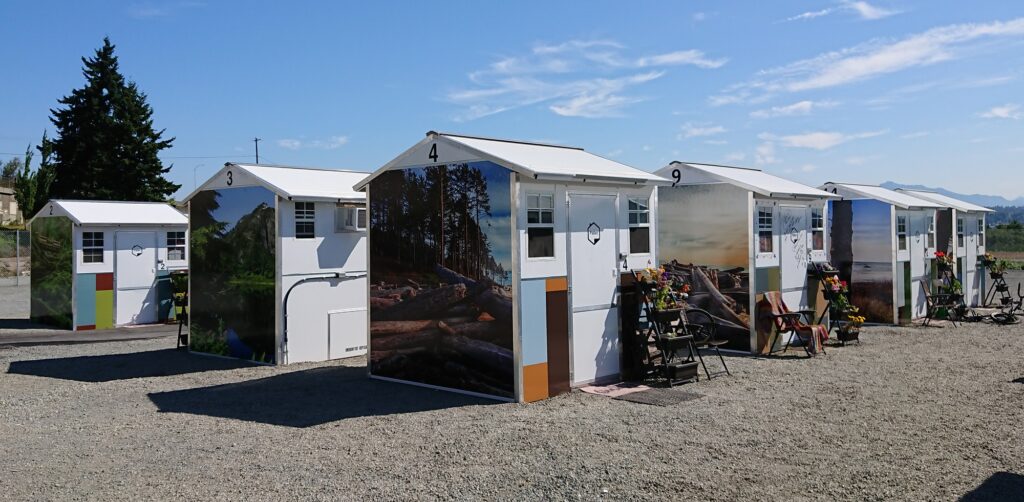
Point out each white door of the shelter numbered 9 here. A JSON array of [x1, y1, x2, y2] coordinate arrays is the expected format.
[[779, 206, 809, 310]]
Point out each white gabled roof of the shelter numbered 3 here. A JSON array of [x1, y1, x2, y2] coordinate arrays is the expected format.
[[183, 162, 369, 202]]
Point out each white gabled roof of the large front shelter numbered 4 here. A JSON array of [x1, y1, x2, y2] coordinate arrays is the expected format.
[[356, 131, 669, 190]]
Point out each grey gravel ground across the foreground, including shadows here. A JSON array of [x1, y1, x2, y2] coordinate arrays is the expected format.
[[0, 325, 1024, 501]]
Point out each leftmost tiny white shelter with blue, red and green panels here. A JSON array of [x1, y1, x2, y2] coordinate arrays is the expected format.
[[29, 200, 188, 331]]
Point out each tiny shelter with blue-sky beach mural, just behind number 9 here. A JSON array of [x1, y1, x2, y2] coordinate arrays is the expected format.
[[821, 182, 941, 324]]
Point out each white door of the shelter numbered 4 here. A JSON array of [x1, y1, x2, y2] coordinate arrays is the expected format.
[[569, 194, 620, 384]]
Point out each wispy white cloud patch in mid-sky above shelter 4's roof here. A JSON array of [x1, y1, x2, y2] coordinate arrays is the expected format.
[[445, 40, 726, 121]]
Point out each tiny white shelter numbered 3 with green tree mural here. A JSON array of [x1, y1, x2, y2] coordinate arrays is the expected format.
[[185, 163, 367, 364]]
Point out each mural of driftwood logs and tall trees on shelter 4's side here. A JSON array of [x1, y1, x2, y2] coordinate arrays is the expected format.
[[370, 162, 515, 398]]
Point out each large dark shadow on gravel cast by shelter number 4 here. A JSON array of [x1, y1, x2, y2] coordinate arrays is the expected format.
[[150, 366, 497, 427]]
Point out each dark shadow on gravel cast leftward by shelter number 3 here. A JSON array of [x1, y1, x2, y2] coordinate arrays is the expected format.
[[7, 348, 252, 383]]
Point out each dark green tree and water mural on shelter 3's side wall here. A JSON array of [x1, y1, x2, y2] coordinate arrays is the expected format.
[[188, 186, 276, 363]]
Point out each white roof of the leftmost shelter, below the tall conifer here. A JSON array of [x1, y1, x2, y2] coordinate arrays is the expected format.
[[32, 199, 188, 225]]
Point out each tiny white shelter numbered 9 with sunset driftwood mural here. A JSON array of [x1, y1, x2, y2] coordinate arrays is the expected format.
[[655, 162, 836, 353]]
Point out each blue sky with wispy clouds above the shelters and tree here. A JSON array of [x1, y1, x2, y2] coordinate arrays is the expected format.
[[0, 0, 1024, 197]]
